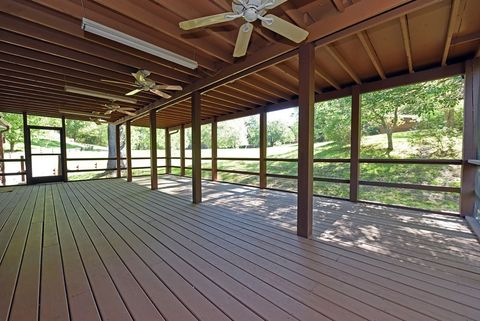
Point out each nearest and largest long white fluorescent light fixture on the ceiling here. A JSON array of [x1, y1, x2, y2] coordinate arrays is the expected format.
[[82, 18, 198, 69]]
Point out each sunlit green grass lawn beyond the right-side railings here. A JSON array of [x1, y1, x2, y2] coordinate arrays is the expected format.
[[198, 132, 461, 212]]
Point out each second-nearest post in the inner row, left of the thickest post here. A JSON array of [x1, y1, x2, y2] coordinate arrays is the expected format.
[[192, 91, 202, 204]]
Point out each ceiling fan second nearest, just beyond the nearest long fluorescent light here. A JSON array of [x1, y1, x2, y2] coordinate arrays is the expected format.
[[102, 69, 183, 99]]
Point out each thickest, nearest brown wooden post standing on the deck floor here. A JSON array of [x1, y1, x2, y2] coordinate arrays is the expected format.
[[297, 43, 315, 238]]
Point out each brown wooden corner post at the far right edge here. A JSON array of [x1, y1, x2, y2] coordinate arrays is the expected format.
[[460, 58, 480, 216]]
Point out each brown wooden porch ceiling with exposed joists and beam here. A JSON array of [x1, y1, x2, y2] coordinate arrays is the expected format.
[[0, 0, 480, 127]]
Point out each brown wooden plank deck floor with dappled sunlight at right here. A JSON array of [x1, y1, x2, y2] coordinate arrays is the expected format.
[[0, 176, 480, 321]]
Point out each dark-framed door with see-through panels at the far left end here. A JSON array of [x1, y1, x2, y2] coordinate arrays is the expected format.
[[25, 125, 67, 184]]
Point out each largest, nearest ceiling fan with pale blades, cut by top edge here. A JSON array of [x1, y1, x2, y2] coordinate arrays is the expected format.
[[179, 0, 308, 57]]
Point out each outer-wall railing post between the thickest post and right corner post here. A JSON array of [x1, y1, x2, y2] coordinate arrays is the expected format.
[[350, 86, 362, 202]]
